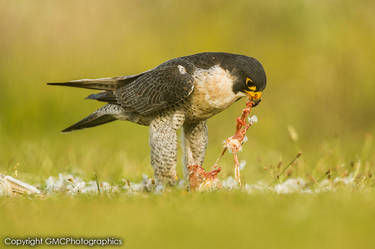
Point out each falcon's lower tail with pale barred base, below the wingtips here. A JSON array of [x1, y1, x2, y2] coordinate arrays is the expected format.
[[62, 104, 123, 133]]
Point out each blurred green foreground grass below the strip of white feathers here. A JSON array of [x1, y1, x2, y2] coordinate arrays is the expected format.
[[1, 192, 375, 248]]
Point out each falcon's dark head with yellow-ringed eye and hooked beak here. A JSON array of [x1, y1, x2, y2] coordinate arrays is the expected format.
[[226, 55, 266, 106]]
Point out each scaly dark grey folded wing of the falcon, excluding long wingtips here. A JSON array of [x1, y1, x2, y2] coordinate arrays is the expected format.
[[115, 58, 194, 115]]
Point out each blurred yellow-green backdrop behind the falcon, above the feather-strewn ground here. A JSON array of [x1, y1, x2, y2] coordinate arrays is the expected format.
[[0, 0, 375, 248]]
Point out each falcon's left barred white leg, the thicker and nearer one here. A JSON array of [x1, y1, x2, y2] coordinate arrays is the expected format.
[[150, 112, 184, 185]]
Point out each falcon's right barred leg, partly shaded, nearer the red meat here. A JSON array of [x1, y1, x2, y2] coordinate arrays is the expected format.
[[182, 121, 208, 179]]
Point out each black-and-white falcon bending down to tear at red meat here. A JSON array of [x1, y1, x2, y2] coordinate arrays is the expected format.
[[48, 52, 266, 185]]
